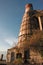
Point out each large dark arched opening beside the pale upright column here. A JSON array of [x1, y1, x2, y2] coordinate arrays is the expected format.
[[30, 16, 39, 30]]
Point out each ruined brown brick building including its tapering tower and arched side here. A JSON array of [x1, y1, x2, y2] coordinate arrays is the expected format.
[[7, 4, 43, 63]]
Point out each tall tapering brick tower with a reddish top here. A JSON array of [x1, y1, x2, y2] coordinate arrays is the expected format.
[[18, 4, 33, 46]]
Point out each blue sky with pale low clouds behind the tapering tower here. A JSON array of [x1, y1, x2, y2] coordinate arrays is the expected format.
[[0, 0, 43, 51]]
